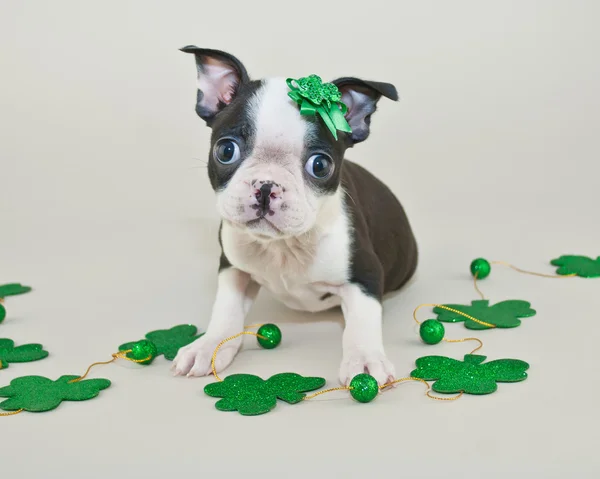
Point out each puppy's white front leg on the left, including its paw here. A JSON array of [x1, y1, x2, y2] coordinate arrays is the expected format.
[[172, 267, 260, 377]]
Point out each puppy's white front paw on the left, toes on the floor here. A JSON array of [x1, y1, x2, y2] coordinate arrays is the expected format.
[[171, 335, 242, 377]]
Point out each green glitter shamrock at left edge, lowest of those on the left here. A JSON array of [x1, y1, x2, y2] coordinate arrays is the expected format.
[[0, 376, 110, 412]]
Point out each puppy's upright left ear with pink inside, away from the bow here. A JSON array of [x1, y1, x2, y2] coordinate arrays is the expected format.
[[181, 45, 249, 126]]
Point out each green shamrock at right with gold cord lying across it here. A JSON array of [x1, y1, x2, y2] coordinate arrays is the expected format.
[[433, 299, 536, 329]]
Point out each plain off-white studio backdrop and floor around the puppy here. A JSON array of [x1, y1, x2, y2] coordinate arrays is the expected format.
[[0, 0, 600, 479]]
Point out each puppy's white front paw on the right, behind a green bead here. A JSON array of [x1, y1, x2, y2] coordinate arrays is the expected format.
[[340, 348, 396, 386]]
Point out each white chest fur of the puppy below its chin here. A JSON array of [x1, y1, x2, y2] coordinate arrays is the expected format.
[[221, 203, 351, 312]]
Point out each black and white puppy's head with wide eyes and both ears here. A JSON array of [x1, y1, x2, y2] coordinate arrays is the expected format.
[[182, 46, 398, 239]]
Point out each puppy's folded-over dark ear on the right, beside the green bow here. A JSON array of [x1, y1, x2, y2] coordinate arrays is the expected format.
[[333, 77, 398, 143]]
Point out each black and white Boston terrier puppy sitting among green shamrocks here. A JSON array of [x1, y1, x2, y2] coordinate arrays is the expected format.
[[173, 46, 417, 385]]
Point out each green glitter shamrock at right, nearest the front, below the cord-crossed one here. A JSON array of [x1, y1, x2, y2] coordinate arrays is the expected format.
[[410, 354, 529, 394]]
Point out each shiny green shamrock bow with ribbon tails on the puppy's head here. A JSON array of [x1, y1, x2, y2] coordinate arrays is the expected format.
[[287, 75, 352, 140]]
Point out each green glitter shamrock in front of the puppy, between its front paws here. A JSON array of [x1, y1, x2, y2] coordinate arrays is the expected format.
[[204, 373, 325, 416]]
